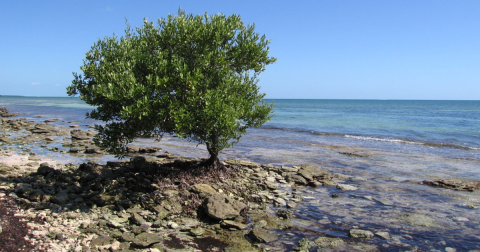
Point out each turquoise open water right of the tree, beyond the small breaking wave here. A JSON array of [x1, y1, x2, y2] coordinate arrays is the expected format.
[[266, 100, 480, 150]]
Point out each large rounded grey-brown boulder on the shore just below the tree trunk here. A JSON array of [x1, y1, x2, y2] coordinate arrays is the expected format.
[[204, 194, 247, 220]]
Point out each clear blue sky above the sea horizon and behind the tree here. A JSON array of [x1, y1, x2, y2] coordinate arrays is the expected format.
[[0, 0, 480, 100]]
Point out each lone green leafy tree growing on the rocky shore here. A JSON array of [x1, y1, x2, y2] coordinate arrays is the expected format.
[[67, 10, 276, 167]]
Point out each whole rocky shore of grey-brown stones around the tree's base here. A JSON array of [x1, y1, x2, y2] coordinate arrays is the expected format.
[[0, 111, 478, 251]]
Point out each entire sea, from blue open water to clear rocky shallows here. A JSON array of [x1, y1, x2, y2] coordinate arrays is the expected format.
[[0, 96, 480, 251]]
